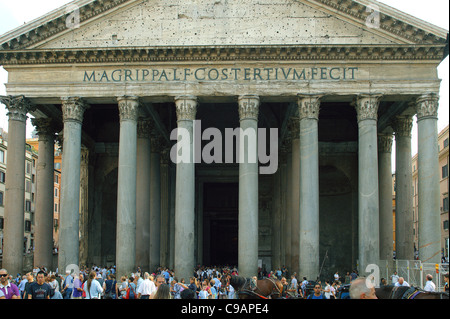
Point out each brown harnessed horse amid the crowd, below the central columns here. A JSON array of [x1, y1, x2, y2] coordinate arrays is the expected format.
[[230, 276, 283, 299]]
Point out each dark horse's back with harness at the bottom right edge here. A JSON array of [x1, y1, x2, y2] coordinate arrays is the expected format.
[[375, 285, 449, 299]]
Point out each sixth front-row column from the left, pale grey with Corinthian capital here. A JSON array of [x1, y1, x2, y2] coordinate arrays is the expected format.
[[297, 95, 321, 280]]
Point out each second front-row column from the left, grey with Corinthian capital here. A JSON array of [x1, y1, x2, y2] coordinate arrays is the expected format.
[[58, 97, 87, 273]]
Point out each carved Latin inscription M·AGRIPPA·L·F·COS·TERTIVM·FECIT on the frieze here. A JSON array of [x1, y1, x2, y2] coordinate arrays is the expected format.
[[83, 67, 358, 83]]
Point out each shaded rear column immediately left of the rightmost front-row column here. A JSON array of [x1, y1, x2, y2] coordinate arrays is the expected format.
[[392, 116, 414, 260]]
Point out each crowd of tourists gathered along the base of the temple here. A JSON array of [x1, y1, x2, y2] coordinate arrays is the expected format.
[[0, 265, 448, 299]]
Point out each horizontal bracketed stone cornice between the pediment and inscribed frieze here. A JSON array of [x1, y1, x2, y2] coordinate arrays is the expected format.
[[0, 44, 446, 65]]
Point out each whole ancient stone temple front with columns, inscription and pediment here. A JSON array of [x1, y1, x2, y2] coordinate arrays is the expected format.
[[0, 0, 448, 278]]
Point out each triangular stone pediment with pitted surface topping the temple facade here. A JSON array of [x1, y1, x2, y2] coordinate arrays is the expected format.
[[0, 0, 447, 49]]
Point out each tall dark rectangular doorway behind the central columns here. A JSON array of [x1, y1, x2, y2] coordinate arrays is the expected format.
[[203, 183, 239, 265]]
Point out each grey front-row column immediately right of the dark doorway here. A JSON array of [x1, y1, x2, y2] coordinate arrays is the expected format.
[[238, 95, 259, 277]]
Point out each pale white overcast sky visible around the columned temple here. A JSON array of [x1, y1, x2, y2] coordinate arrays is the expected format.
[[0, 0, 450, 162]]
